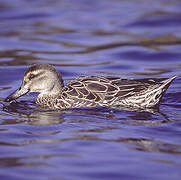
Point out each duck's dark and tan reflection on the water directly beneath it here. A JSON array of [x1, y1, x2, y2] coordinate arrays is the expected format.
[[2, 98, 173, 125]]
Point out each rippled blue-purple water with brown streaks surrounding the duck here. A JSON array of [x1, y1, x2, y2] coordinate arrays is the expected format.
[[0, 0, 181, 180]]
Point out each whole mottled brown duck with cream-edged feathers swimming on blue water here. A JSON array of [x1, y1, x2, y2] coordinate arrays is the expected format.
[[4, 64, 176, 110]]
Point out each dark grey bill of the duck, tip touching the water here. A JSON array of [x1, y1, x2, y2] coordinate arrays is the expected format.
[[4, 87, 29, 102]]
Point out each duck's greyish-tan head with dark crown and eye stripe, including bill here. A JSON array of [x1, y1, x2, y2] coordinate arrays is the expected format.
[[4, 64, 63, 102]]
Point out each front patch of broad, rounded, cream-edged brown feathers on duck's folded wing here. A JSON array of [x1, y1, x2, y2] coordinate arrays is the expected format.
[[62, 76, 112, 103]]
